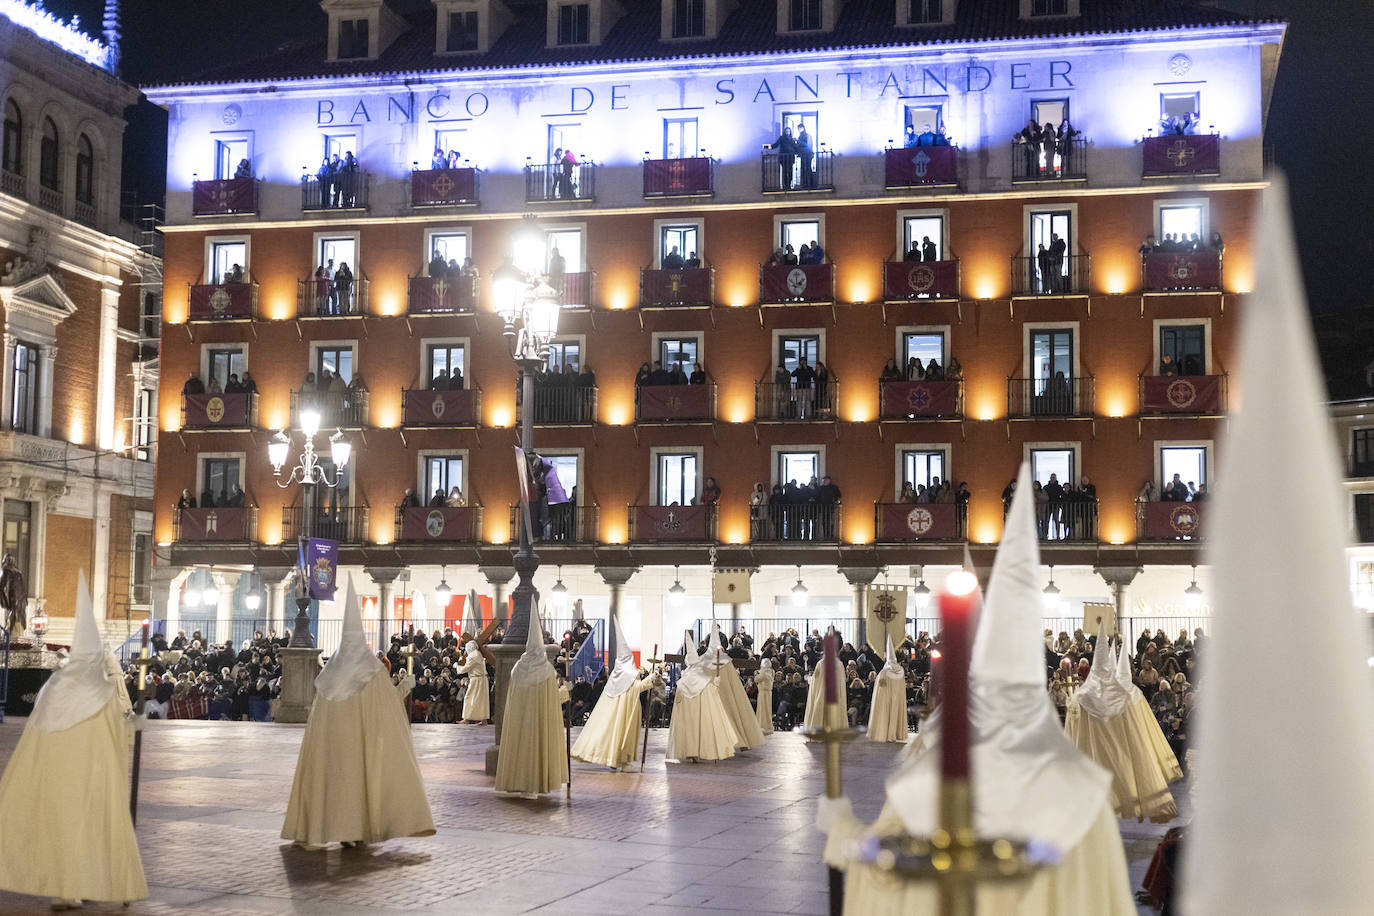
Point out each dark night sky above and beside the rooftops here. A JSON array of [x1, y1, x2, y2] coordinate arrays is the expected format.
[[44, 0, 1374, 314]]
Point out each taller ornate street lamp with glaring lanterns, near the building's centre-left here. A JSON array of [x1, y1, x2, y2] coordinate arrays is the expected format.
[[486, 217, 561, 773]]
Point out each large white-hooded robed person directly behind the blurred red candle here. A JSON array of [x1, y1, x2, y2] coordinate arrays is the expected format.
[[819, 464, 1136, 916]]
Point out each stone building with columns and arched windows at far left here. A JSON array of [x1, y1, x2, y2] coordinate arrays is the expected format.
[[0, 0, 162, 641]]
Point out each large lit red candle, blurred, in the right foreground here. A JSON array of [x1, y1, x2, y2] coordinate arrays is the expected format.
[[936, 571, 978, 780]]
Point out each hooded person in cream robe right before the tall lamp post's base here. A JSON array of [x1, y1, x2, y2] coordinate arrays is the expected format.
[[491, 600, 567, 795]]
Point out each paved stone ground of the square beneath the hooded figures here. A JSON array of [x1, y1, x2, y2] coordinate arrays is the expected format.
[[0, 720, 1186, 916]]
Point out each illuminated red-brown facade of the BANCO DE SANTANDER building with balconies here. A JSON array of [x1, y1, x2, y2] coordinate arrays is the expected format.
[[148, 0, 1283, 645]]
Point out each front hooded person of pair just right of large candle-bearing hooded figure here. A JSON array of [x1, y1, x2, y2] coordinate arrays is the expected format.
[[1063, 625, 1183, 824]]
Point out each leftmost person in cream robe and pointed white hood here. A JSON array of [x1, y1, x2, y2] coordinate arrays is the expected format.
[[0, 570, 146, 906]]
